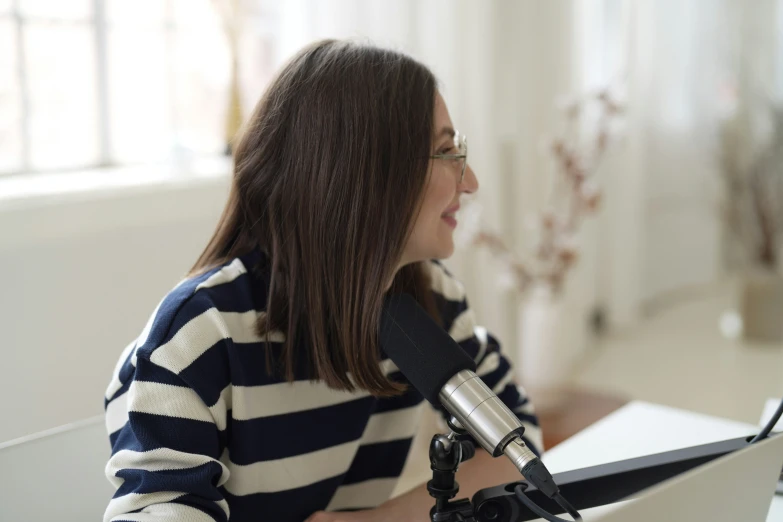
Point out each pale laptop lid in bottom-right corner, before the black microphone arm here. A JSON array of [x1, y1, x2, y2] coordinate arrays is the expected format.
[[561, 434, 783, 522]]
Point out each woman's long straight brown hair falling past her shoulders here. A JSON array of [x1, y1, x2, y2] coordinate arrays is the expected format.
[[192, 40, 437, 396]]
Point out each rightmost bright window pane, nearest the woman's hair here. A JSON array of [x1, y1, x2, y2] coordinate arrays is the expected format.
[[173, 0, 230, 154]]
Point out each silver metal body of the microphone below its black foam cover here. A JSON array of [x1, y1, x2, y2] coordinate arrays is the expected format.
[[438, 370, 537, 472]]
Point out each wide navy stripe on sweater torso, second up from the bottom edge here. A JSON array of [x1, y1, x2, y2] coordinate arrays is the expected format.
[[229, 397, 376, 465]]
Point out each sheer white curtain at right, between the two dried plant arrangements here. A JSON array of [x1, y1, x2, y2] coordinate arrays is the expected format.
[[597, 0, 783, 325]]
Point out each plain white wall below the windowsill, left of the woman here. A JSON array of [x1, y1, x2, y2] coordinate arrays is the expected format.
[[0, 169, 228, 444]]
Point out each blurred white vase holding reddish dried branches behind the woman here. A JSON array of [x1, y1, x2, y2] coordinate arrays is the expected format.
[[517, 285, 585, 410]]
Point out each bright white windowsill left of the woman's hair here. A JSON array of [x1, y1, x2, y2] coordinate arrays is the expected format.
[[0, 157, 232, 250]]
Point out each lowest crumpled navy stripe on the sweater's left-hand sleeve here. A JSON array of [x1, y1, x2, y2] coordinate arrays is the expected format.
[[114, 462, 223, 502]]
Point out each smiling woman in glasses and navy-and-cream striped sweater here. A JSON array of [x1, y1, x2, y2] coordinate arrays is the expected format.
[[105, 41, 541, 521]]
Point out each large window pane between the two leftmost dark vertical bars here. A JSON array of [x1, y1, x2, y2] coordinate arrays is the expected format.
[[24, 23, 98, 169]]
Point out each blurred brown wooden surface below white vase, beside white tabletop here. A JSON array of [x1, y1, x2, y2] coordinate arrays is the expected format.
[[533, 389, 628, 450]]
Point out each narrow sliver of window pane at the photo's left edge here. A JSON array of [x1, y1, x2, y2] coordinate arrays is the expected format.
[[0, 19, 22, 174]]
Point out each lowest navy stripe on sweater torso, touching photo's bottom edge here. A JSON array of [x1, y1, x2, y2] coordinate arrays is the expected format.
[[223, 475, 344, 522]]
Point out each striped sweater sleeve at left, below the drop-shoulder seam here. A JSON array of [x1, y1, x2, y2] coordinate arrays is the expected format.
[[104, 357, 229, 522]]
